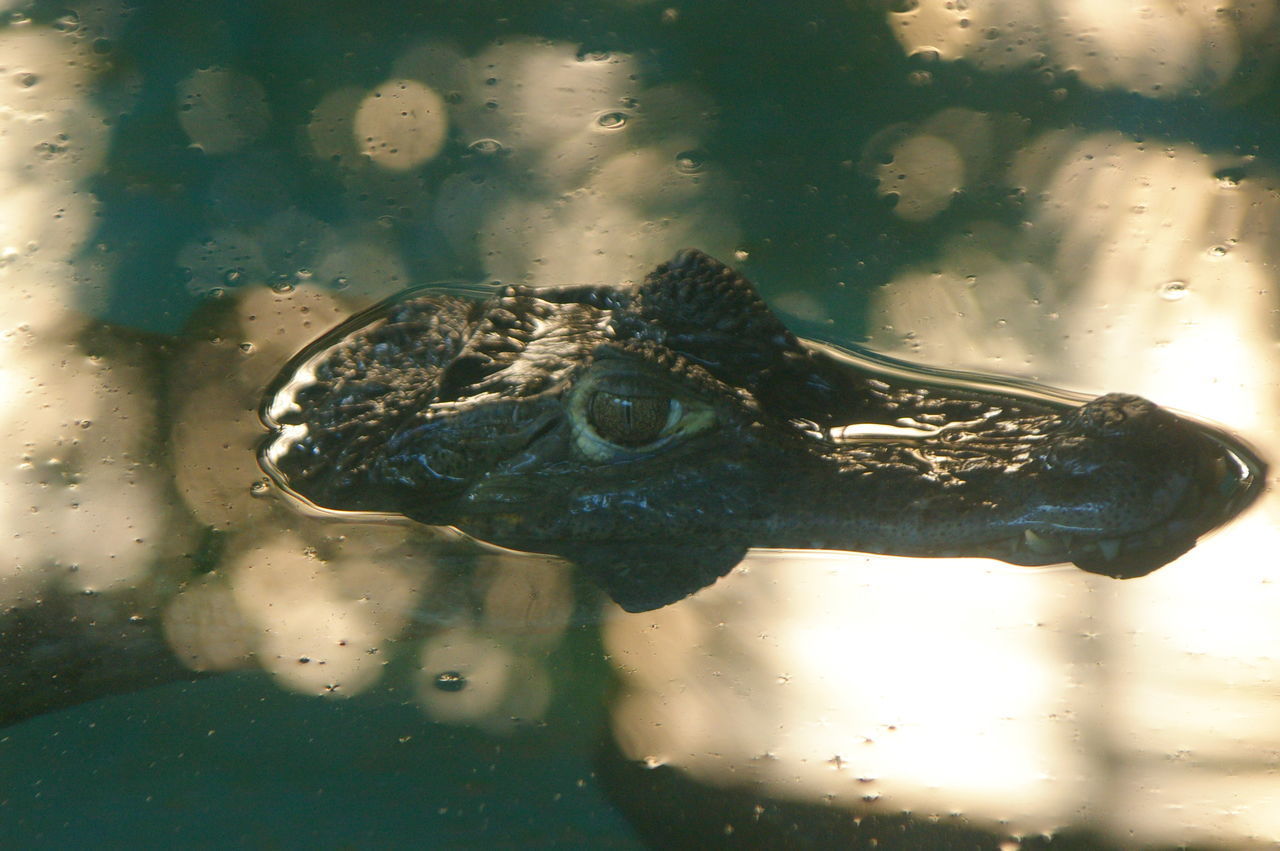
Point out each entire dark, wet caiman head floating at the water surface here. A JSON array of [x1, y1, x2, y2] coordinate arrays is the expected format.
[[261, 251, 1263, 610]]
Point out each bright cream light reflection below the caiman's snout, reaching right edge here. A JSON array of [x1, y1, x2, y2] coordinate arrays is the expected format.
[[605, 522, 1280, 843]]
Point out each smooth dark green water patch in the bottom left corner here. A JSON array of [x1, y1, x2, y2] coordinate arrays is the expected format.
[[0, 631, 643, 848]]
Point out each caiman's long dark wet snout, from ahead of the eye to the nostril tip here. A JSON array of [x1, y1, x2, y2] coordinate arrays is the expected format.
[[788, 395, 1266, 577]]
